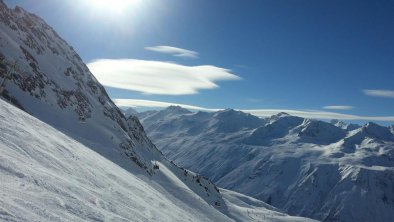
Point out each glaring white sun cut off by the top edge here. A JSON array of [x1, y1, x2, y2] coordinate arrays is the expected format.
[[87, 0, 141, 15]]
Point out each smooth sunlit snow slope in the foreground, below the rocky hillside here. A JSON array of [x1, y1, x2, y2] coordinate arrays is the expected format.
[[0, 99, 318, 221]]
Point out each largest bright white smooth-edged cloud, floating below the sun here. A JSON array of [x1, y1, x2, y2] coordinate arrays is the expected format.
[[87, 59, 241, 95]]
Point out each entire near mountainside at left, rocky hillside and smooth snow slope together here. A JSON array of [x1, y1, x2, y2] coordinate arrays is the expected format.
[[0, 0, 314, 221]]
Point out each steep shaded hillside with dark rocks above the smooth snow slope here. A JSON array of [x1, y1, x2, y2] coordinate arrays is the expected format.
[[0, 1, 172, 186]]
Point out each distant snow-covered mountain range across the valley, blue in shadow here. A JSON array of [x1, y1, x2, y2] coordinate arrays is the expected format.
[[139, 106, 394, 221]]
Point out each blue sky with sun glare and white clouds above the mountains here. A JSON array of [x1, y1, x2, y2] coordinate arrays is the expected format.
[[5, 0, 394, 124]]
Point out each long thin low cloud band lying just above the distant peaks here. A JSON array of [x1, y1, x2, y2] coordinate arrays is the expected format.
[[114, 99, 394, 122]]
